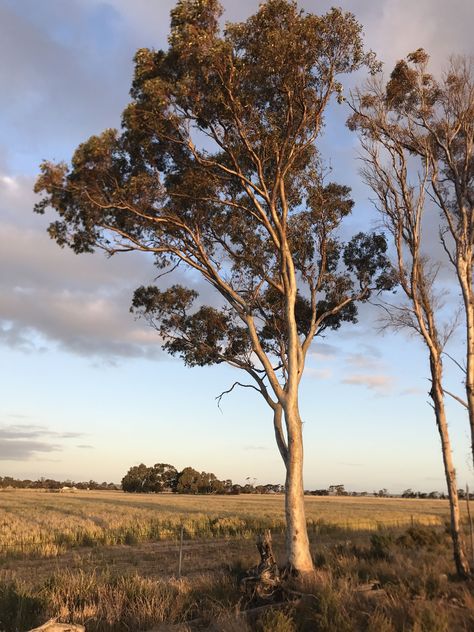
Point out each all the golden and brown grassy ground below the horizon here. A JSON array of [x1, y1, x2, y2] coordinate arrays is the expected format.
[[0, 491, 474, 632]]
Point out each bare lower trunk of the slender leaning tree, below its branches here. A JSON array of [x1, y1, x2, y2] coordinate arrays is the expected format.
[[430, 357, 471, 579]]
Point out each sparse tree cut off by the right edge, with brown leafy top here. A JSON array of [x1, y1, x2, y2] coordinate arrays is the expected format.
[[350, 49, 474, 459]]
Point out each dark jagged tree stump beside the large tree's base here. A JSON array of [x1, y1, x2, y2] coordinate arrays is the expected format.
[[241, 529, 281, 601]]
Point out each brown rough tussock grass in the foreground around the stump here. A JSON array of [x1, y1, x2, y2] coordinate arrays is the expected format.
[[0, 527, 474, 632]]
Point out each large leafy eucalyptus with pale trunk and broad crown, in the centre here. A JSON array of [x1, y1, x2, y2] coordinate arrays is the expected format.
[[36, 0, 393, 573]]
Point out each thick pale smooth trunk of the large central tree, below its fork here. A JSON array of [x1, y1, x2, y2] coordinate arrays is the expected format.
[[284, 396, 314, 575]]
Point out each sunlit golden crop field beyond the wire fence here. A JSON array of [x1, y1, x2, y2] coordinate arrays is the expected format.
[[0, 490, 456, 557]]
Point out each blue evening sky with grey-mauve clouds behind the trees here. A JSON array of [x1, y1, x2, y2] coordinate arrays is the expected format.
[[0, 0, 474, 493]]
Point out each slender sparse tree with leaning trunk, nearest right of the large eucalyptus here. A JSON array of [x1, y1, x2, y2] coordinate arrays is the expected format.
[[351, 84, 472, 578]]
